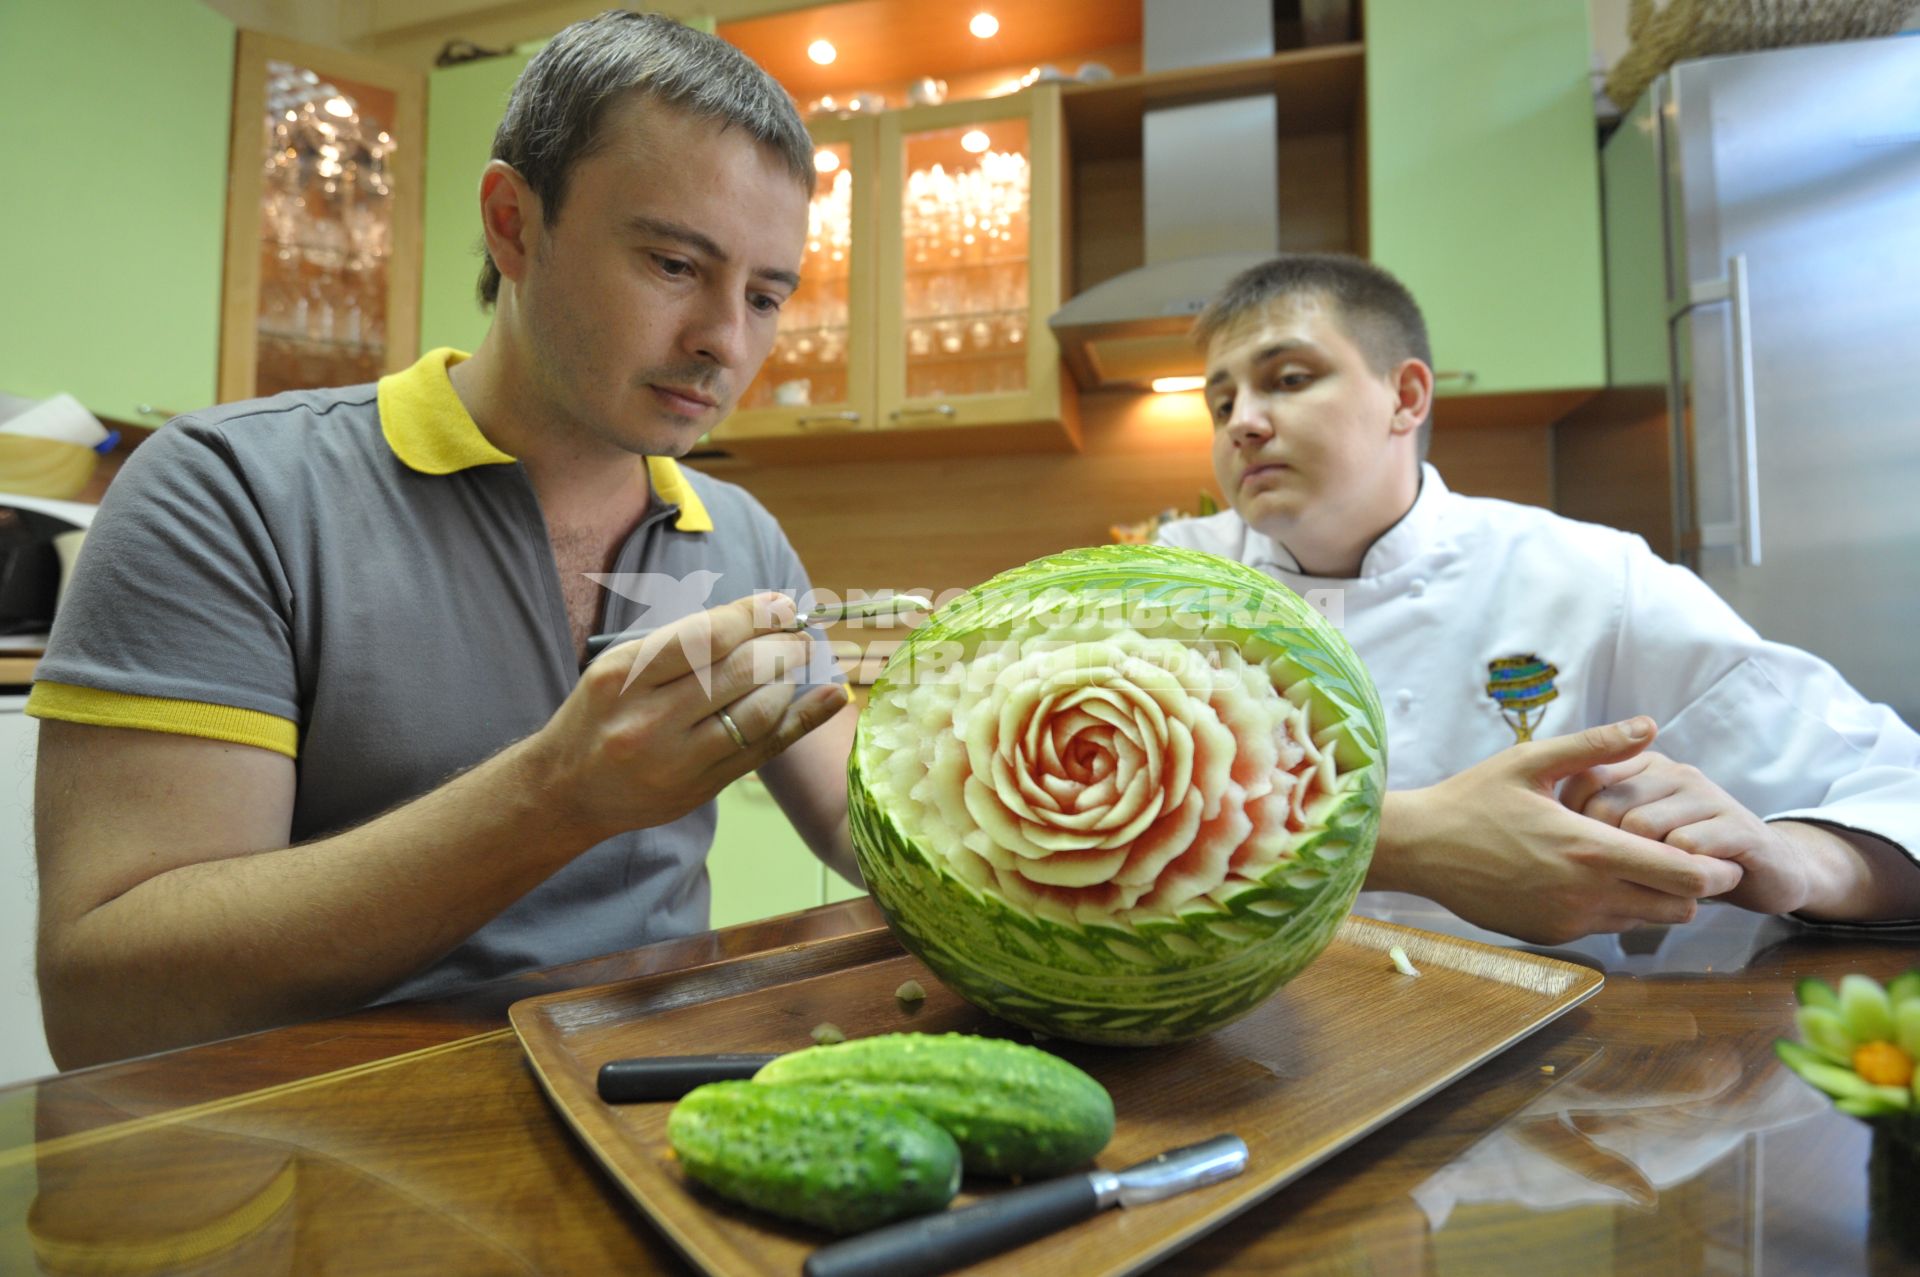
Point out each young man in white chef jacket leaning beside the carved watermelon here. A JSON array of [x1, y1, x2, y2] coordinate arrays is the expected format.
[[1160, 253, 1920, 943]]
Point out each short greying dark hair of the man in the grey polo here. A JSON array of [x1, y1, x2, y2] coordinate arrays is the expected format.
[[478, 10, 816, 305]]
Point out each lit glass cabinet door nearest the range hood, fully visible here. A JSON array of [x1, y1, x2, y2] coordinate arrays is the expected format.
[[879, 86, 1064, 430]]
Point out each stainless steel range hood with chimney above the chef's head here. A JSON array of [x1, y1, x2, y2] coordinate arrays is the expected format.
[[1046, 0, 1281, 390]]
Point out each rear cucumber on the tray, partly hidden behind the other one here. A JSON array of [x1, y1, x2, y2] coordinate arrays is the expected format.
[[753, 1033, 1114, 1179]]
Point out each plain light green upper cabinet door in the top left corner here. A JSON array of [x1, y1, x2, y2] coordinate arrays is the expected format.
[[0, 0, 234, 424]]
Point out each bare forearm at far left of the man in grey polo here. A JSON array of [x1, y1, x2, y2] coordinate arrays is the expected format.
[[40, 741, 597, 1068]]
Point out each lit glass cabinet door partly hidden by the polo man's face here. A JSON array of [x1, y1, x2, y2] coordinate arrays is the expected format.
[[714, 119, 874, 446]]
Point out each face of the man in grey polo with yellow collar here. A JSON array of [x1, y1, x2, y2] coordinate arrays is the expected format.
[[516, 98, 806, 457]]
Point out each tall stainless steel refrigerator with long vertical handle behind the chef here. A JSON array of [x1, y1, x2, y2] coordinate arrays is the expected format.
[[1601, 36, 1920, 724]]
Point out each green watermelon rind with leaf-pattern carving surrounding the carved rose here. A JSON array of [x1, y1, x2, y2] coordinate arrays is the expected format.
[[849, 545, 1386, 1045]]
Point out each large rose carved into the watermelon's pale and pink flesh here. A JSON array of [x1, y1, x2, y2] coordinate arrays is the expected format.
[[906, 632, 1334, 920]]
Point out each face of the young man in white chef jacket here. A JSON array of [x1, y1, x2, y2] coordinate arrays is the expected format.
[[1206, 296, 1419, 553]]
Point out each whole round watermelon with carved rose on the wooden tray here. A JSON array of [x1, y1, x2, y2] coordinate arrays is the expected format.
[[849, 545, 1386, 1045]]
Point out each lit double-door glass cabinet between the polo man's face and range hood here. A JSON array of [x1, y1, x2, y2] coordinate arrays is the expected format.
[[714, 84, 1079, 461]]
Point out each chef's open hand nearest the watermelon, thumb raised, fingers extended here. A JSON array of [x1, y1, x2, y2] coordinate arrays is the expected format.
[[1367, 718, 1741, 945]]
